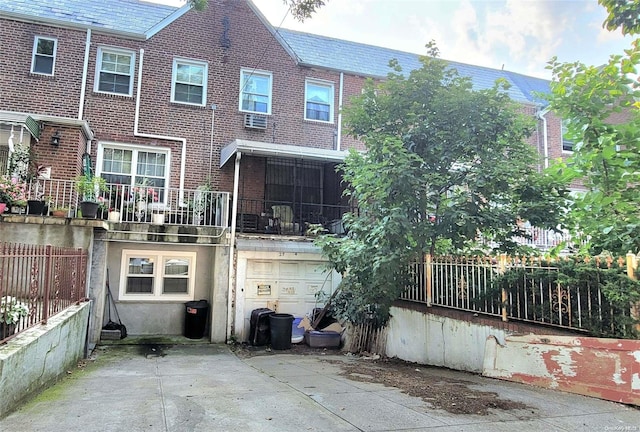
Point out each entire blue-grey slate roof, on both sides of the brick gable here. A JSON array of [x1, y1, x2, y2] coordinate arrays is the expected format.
[[0, 0, 549, 103]]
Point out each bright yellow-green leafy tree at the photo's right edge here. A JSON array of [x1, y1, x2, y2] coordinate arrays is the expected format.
[[548, 40, 640, 254]]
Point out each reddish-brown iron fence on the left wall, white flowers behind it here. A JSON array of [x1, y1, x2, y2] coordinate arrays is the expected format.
[[0, 243, 87, 343]]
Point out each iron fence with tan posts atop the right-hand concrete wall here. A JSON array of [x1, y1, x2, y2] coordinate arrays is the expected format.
[[401, 255, 637, 335]]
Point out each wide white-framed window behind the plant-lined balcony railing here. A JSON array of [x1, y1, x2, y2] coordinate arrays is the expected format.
[[96, 143, 171, 208]]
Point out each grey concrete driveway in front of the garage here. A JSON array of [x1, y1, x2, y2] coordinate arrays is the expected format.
[[0, 345, 640, 432]]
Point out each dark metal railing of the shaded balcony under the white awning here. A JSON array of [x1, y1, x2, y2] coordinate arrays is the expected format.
[[236, 199, 358, 235]]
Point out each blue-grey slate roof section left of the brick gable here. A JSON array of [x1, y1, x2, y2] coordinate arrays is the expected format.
[[0, 0, 177, 35]]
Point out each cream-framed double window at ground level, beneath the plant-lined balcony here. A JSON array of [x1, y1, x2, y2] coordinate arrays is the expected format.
[[119, 249, 196, 301]]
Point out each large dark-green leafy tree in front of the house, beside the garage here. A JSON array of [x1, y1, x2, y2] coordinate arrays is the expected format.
[[318, 47, 562, 324]]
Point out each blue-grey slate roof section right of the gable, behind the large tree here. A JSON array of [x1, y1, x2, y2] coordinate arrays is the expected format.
[[278, 29, 549, 103]]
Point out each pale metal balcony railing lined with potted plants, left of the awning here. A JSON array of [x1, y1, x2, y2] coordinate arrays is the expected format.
[[4, 180, 229, 228]]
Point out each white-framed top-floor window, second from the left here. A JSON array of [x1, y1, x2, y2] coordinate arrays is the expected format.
[[94, 47, 136, 96]]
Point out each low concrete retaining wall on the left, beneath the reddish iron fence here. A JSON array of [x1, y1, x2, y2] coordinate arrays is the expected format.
[[0, 302, 91, 417]]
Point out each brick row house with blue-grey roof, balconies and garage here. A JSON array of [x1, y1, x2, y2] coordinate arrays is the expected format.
[[0, 0, 570, 342]]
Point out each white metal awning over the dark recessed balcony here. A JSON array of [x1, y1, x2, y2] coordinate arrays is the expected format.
[[220, 139, 347, 167]]
